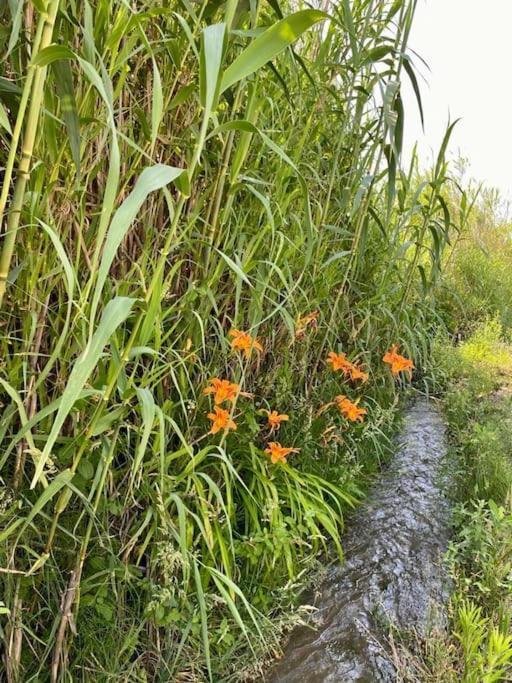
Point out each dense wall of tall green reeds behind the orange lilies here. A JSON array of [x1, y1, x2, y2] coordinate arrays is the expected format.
[[0, 0, 465, 681]]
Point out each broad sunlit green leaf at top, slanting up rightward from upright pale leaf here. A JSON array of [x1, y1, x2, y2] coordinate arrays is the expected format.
[[221, 9, 328, 92]]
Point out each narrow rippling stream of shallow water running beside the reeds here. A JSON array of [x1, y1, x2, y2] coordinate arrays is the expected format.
[[265, 400, 450, 683]]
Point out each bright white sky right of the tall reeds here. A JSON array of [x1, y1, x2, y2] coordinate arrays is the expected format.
[[403, 0, 512, 198]]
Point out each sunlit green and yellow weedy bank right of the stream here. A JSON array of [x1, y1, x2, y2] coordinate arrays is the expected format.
[[395, 188, 512, 683]]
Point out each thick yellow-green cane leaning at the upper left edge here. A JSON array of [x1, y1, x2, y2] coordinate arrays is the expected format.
[[0, 0, 59, 305]]
